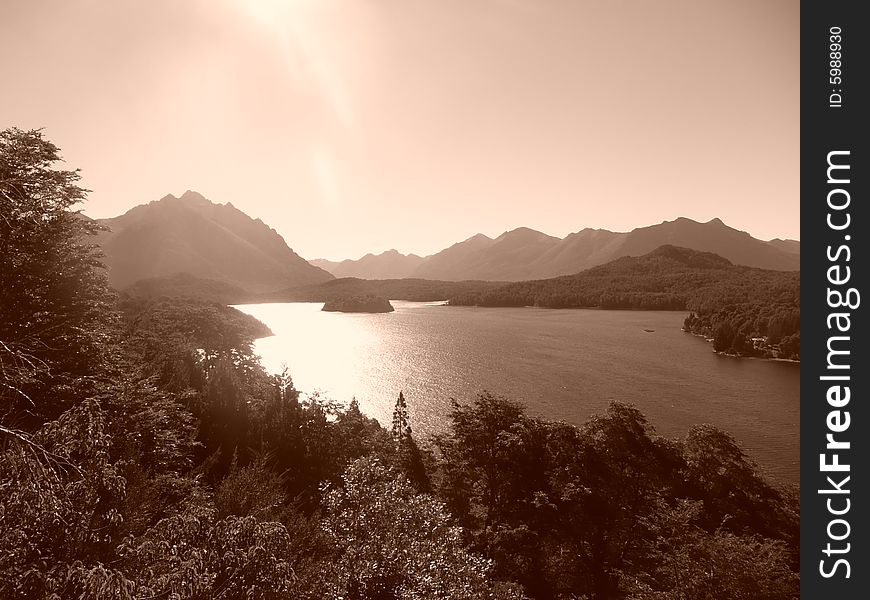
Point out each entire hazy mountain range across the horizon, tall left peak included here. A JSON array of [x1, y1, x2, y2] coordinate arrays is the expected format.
[[96, 191, 800, 296]]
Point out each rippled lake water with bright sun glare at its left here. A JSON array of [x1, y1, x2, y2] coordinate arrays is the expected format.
[[236, 301, 800, 483]]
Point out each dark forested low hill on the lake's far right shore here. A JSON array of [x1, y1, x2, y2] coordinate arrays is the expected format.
[[450, 246, 800, 359]]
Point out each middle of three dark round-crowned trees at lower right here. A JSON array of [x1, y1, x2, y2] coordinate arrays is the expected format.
[[550, 402, 679, 600]]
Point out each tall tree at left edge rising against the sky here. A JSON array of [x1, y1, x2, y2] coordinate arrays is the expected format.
[[0, 128, 112, 430]]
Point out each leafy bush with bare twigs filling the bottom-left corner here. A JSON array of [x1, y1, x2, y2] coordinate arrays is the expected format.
[[0, 401, 126, 600]]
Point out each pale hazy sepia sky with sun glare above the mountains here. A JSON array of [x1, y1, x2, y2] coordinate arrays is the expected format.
[[0, 0, 800, 259]]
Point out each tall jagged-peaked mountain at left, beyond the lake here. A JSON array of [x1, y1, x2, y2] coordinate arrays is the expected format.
[[96, 190, 334, 293]]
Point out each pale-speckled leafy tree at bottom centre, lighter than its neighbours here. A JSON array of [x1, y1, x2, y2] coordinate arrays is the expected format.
[[316, 458, 521, 600]]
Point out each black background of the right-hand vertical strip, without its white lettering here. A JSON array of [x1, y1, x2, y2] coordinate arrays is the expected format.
[[800, 0, 870, 600]]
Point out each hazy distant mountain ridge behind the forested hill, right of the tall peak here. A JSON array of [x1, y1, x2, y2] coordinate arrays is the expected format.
[[312, 217, 800, 281]]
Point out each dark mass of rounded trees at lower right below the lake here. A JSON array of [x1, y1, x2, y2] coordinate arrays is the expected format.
[[434, 394, 798, 599]]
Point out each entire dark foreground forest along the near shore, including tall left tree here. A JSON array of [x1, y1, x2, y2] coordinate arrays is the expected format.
[[0, 130, 798, 600]]
